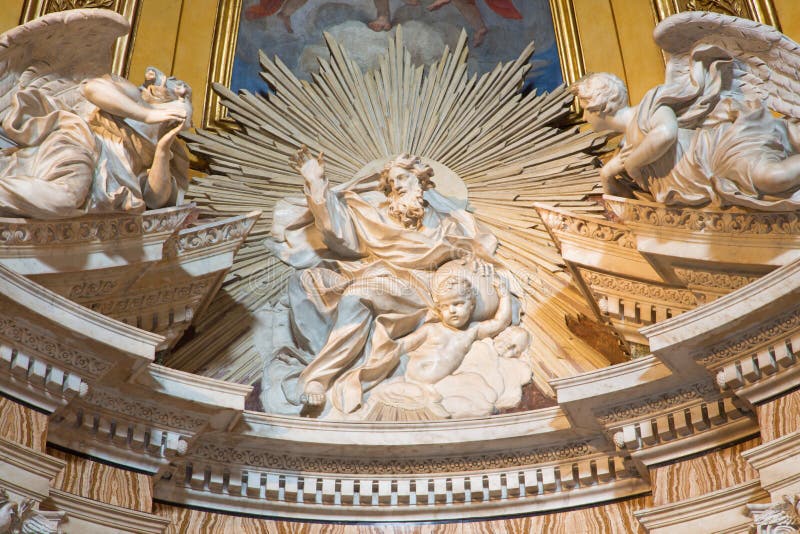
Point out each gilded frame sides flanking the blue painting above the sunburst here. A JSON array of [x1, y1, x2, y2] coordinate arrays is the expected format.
[[203, 0, 585, 129]]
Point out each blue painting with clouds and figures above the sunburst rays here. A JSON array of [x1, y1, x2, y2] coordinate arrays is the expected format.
[[231, 0, 563, 97]]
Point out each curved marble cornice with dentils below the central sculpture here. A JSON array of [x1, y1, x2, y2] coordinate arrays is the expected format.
[[0, 218, 800, 521]]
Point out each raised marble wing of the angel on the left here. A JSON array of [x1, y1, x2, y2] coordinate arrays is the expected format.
[[0, 9, 130, 118]]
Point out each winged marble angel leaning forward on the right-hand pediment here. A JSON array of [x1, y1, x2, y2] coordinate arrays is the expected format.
[[572, 12, 800, 211]]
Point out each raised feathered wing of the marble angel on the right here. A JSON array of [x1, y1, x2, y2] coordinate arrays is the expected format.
[[653, 11, 800, 118]]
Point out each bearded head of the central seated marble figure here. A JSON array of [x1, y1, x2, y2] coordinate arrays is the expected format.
[[380, 154, 434, 229]]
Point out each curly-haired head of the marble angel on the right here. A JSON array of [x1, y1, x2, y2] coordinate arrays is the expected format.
[[569, 72, 628, 131]]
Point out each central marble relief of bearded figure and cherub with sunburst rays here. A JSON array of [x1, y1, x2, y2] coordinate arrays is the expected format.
[[181, 28, 605, 421]]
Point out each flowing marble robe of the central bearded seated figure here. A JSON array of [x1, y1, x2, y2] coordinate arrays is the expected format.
[[267, 172, 506, 413]]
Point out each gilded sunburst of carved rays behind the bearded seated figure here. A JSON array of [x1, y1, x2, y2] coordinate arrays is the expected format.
[[173, 29, 608, 398]]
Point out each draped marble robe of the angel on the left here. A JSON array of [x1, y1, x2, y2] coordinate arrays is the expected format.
[[0, 76, 189, 219]]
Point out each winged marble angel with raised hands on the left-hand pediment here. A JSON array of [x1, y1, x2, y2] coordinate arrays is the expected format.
[[0, 9, 192, 219]]
